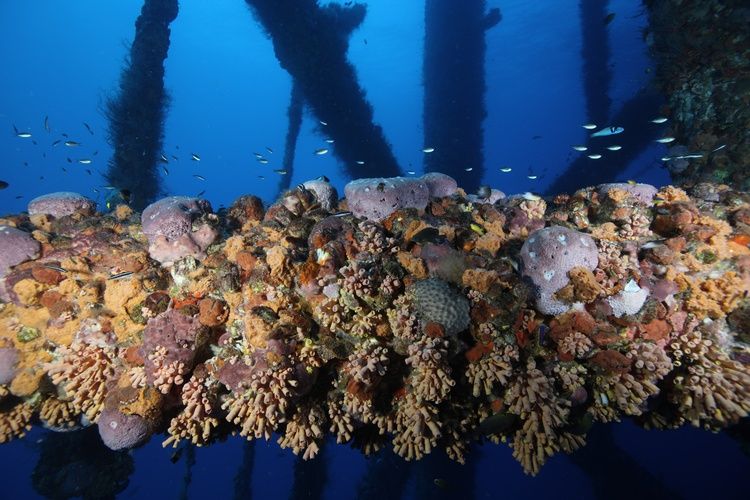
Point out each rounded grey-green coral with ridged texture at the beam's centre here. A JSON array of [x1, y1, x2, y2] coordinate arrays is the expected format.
[[408, 278, 470, 335]]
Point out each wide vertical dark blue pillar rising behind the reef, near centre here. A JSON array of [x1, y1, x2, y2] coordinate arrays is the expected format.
[[422, 0, 502, 191]]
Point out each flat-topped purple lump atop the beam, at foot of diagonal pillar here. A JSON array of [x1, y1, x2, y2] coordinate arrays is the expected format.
[[344, 177, 430, 221]]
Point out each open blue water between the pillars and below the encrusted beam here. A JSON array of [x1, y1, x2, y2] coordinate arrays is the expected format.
[[0, 0, 750, 498]]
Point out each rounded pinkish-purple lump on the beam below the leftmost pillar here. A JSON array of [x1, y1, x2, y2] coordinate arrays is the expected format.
[[141, 196, 218, 265]]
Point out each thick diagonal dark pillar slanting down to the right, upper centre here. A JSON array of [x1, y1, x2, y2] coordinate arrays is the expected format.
[[246, 0, 400, 178]]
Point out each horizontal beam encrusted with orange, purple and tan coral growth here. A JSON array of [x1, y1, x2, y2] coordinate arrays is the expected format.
[[0, 174, 750, 474]]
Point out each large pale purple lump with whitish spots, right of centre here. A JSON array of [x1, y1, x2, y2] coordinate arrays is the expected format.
[[521, 226, 599, 315]]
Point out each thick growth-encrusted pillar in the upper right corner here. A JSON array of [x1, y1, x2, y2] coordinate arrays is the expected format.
[[644, 0, 750, 191]]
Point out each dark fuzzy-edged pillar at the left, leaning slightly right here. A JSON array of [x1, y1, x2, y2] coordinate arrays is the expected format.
[[106, 0, 178, 210]]
